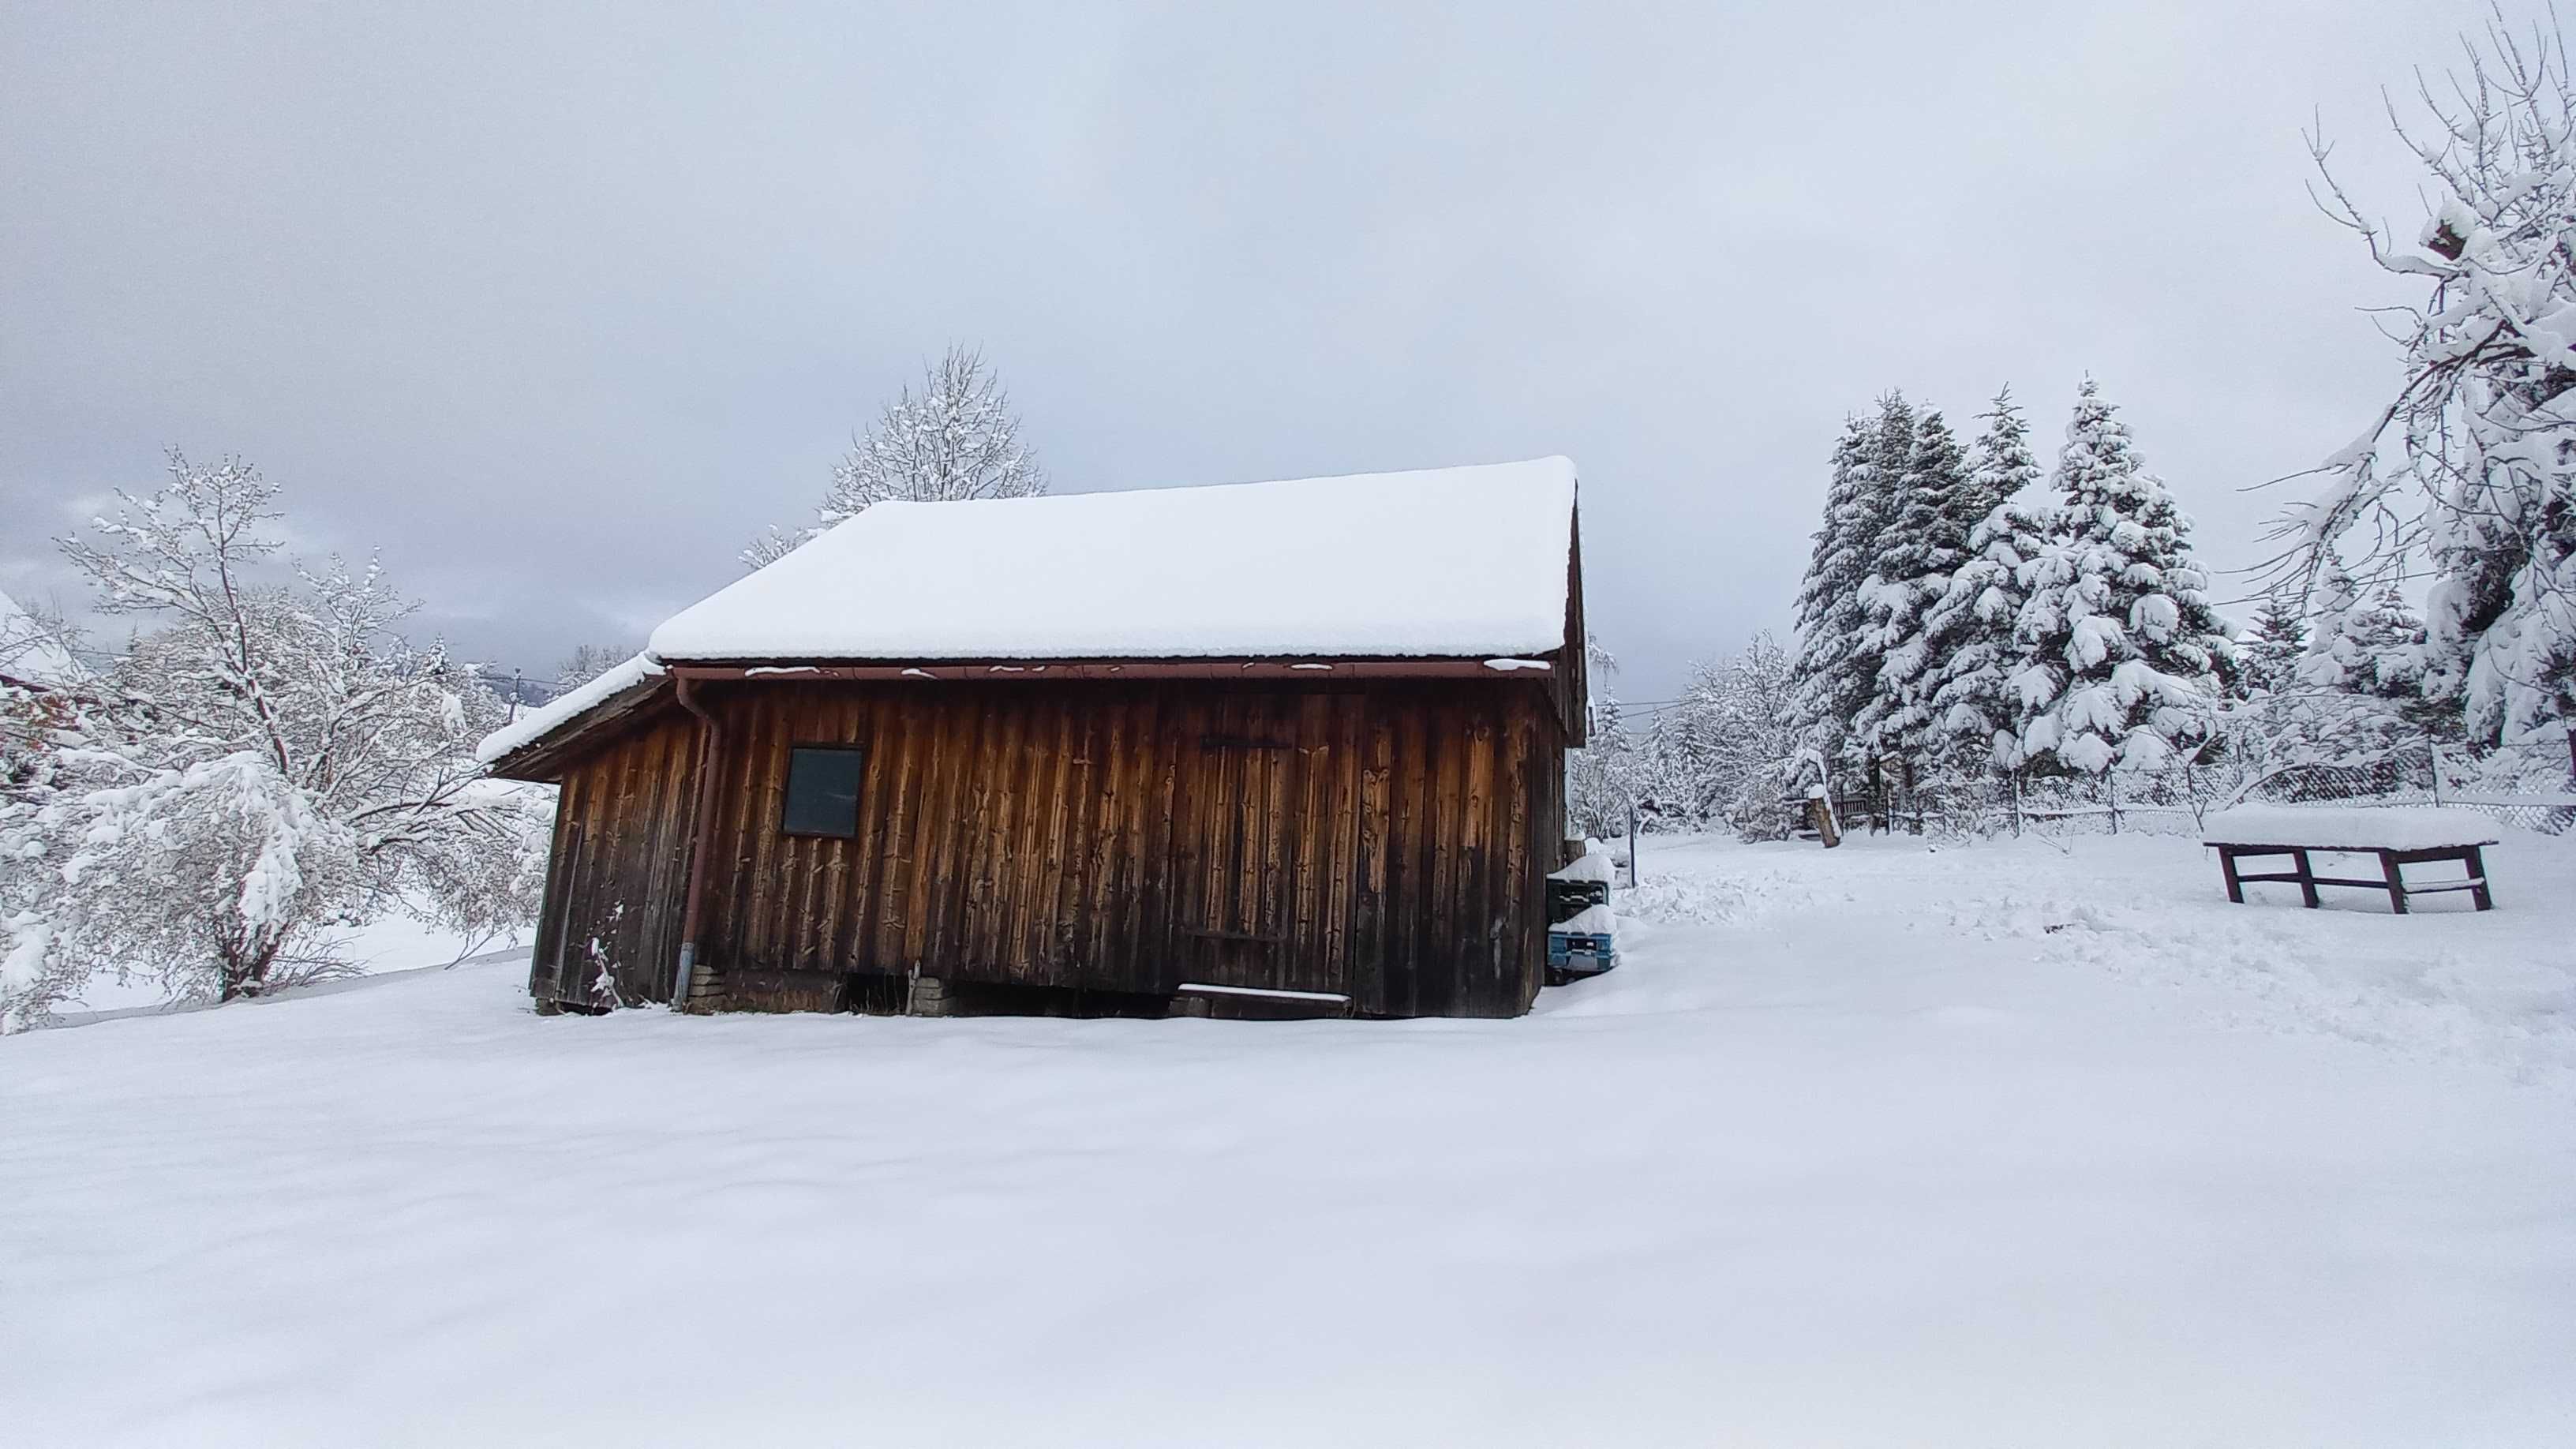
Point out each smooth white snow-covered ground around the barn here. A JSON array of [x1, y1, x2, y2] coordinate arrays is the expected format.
[[0, 833, 2576, 1447]]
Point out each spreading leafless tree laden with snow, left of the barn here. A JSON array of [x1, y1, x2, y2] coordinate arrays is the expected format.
[[0, 454, 546, 1024]]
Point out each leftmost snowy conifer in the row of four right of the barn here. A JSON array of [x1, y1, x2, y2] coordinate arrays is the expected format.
[[1788, 392, 1914, 769]]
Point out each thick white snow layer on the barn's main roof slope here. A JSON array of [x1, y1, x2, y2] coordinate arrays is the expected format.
[[650, 459, 1574, 660]]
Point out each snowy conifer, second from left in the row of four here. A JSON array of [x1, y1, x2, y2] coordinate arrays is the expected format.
[[1857, 399, 1986, 771]]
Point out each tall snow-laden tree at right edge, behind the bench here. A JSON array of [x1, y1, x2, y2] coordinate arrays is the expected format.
[[2287, 18, 2576, 743]]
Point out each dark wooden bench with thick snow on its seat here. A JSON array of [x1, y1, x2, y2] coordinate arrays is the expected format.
[[2200, 807, 2496, 915]]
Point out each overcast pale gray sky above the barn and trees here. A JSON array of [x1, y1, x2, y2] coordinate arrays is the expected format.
[[0, 0, 2493, 698]]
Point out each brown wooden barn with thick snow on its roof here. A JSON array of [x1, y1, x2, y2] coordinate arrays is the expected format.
[[481, 459, 1584, 1016]]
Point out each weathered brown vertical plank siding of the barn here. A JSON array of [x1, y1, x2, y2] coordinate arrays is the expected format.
[[538, 680, 1563, 1016]]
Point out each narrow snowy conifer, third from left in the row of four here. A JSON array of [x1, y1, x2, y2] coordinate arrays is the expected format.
[[1924, 387, 2042, 773]]
